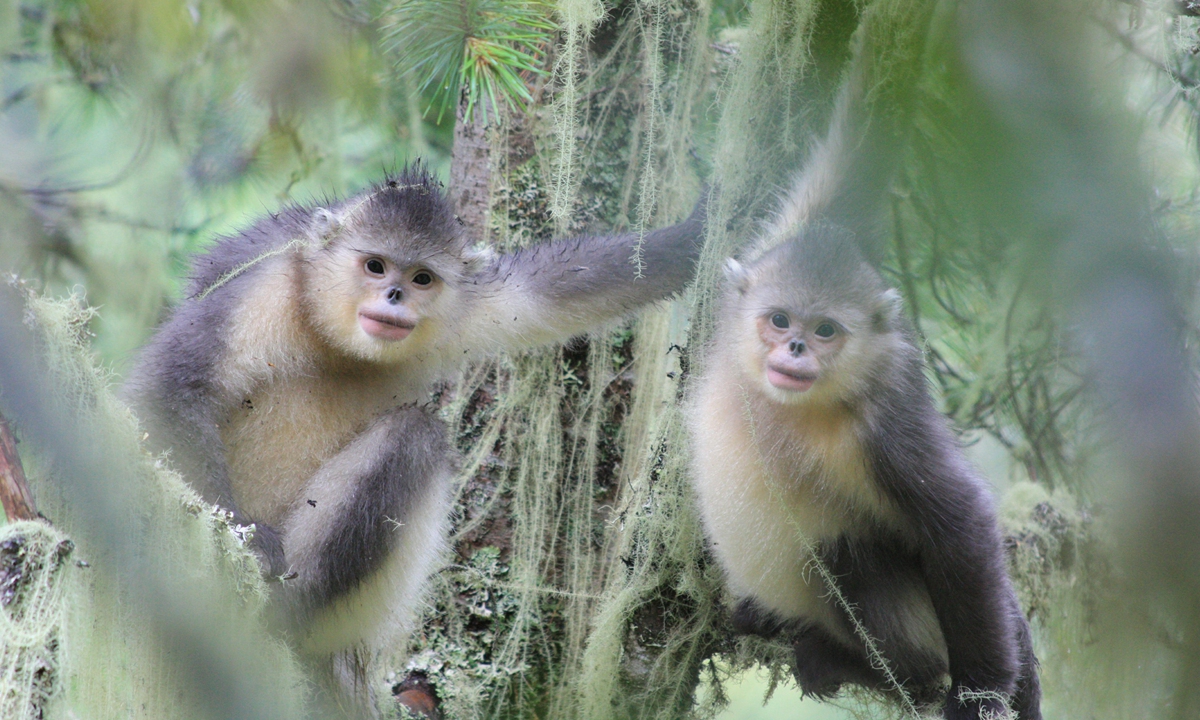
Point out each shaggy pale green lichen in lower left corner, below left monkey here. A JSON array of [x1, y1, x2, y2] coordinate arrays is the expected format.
[[0, 295, 310, 720]]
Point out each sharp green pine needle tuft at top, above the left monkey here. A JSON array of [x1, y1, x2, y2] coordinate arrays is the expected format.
[[383, 0, 556, 122]]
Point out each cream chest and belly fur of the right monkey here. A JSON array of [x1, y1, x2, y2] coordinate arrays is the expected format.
[[691, 380, 894, 628]]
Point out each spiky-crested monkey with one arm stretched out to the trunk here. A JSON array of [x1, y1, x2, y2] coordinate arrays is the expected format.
[[125, 167, 703, 710]]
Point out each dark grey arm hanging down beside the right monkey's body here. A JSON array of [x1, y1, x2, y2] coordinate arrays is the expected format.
[[865, 374, 1032, 719]]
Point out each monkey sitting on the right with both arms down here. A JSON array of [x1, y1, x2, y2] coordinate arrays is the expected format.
[[690, 231, 1040, 720]]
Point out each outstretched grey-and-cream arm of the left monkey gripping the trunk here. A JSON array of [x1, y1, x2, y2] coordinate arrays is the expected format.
[[463, 194, 706, 349]]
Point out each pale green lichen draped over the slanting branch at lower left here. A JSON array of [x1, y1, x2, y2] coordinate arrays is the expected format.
[[0, 296, 307, 719]]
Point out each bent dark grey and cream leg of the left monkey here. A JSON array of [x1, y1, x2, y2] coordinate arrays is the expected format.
[[277, 407, 451, 655]]
